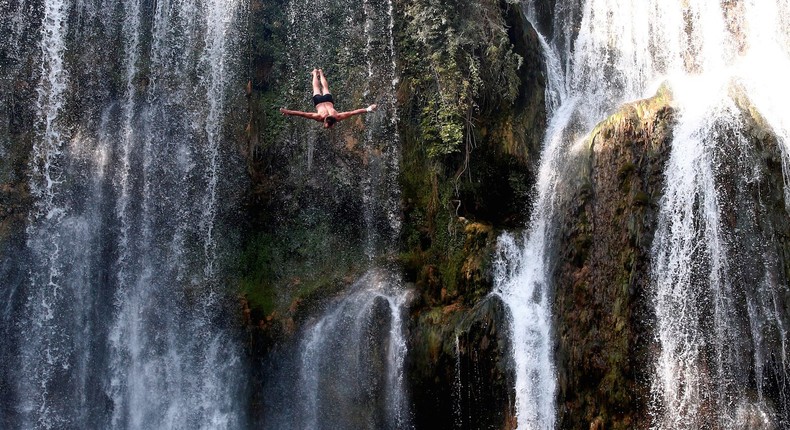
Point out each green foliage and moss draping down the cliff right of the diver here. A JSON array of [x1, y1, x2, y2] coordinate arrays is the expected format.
[[397, 0, 526, 303]]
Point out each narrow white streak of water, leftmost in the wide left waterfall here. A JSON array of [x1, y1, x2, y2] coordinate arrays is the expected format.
[[20, 0, 72, 429]]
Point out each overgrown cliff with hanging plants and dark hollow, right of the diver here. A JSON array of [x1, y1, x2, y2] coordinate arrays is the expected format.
[[396, 0, 543, 310]]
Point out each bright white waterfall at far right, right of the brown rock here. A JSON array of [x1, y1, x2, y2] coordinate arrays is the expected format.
[[651, 1, 790, 428]]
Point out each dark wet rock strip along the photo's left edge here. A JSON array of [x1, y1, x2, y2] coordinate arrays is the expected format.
[[0, 8, 40, 404]]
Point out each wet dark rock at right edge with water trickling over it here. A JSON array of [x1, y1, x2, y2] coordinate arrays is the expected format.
[[703, 90, 790, 429]]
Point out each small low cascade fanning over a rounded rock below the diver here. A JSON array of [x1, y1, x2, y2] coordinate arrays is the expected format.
[[298, 270, 409, 429]]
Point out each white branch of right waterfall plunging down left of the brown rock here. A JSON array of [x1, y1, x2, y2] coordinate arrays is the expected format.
[[496, 0, 780, 428]]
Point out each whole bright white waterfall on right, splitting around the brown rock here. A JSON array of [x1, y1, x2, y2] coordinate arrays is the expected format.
[[496, 0, 788, 428]]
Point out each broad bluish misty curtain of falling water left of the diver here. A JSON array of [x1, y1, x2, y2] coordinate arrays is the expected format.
[[2, 0, 244, 428]]
